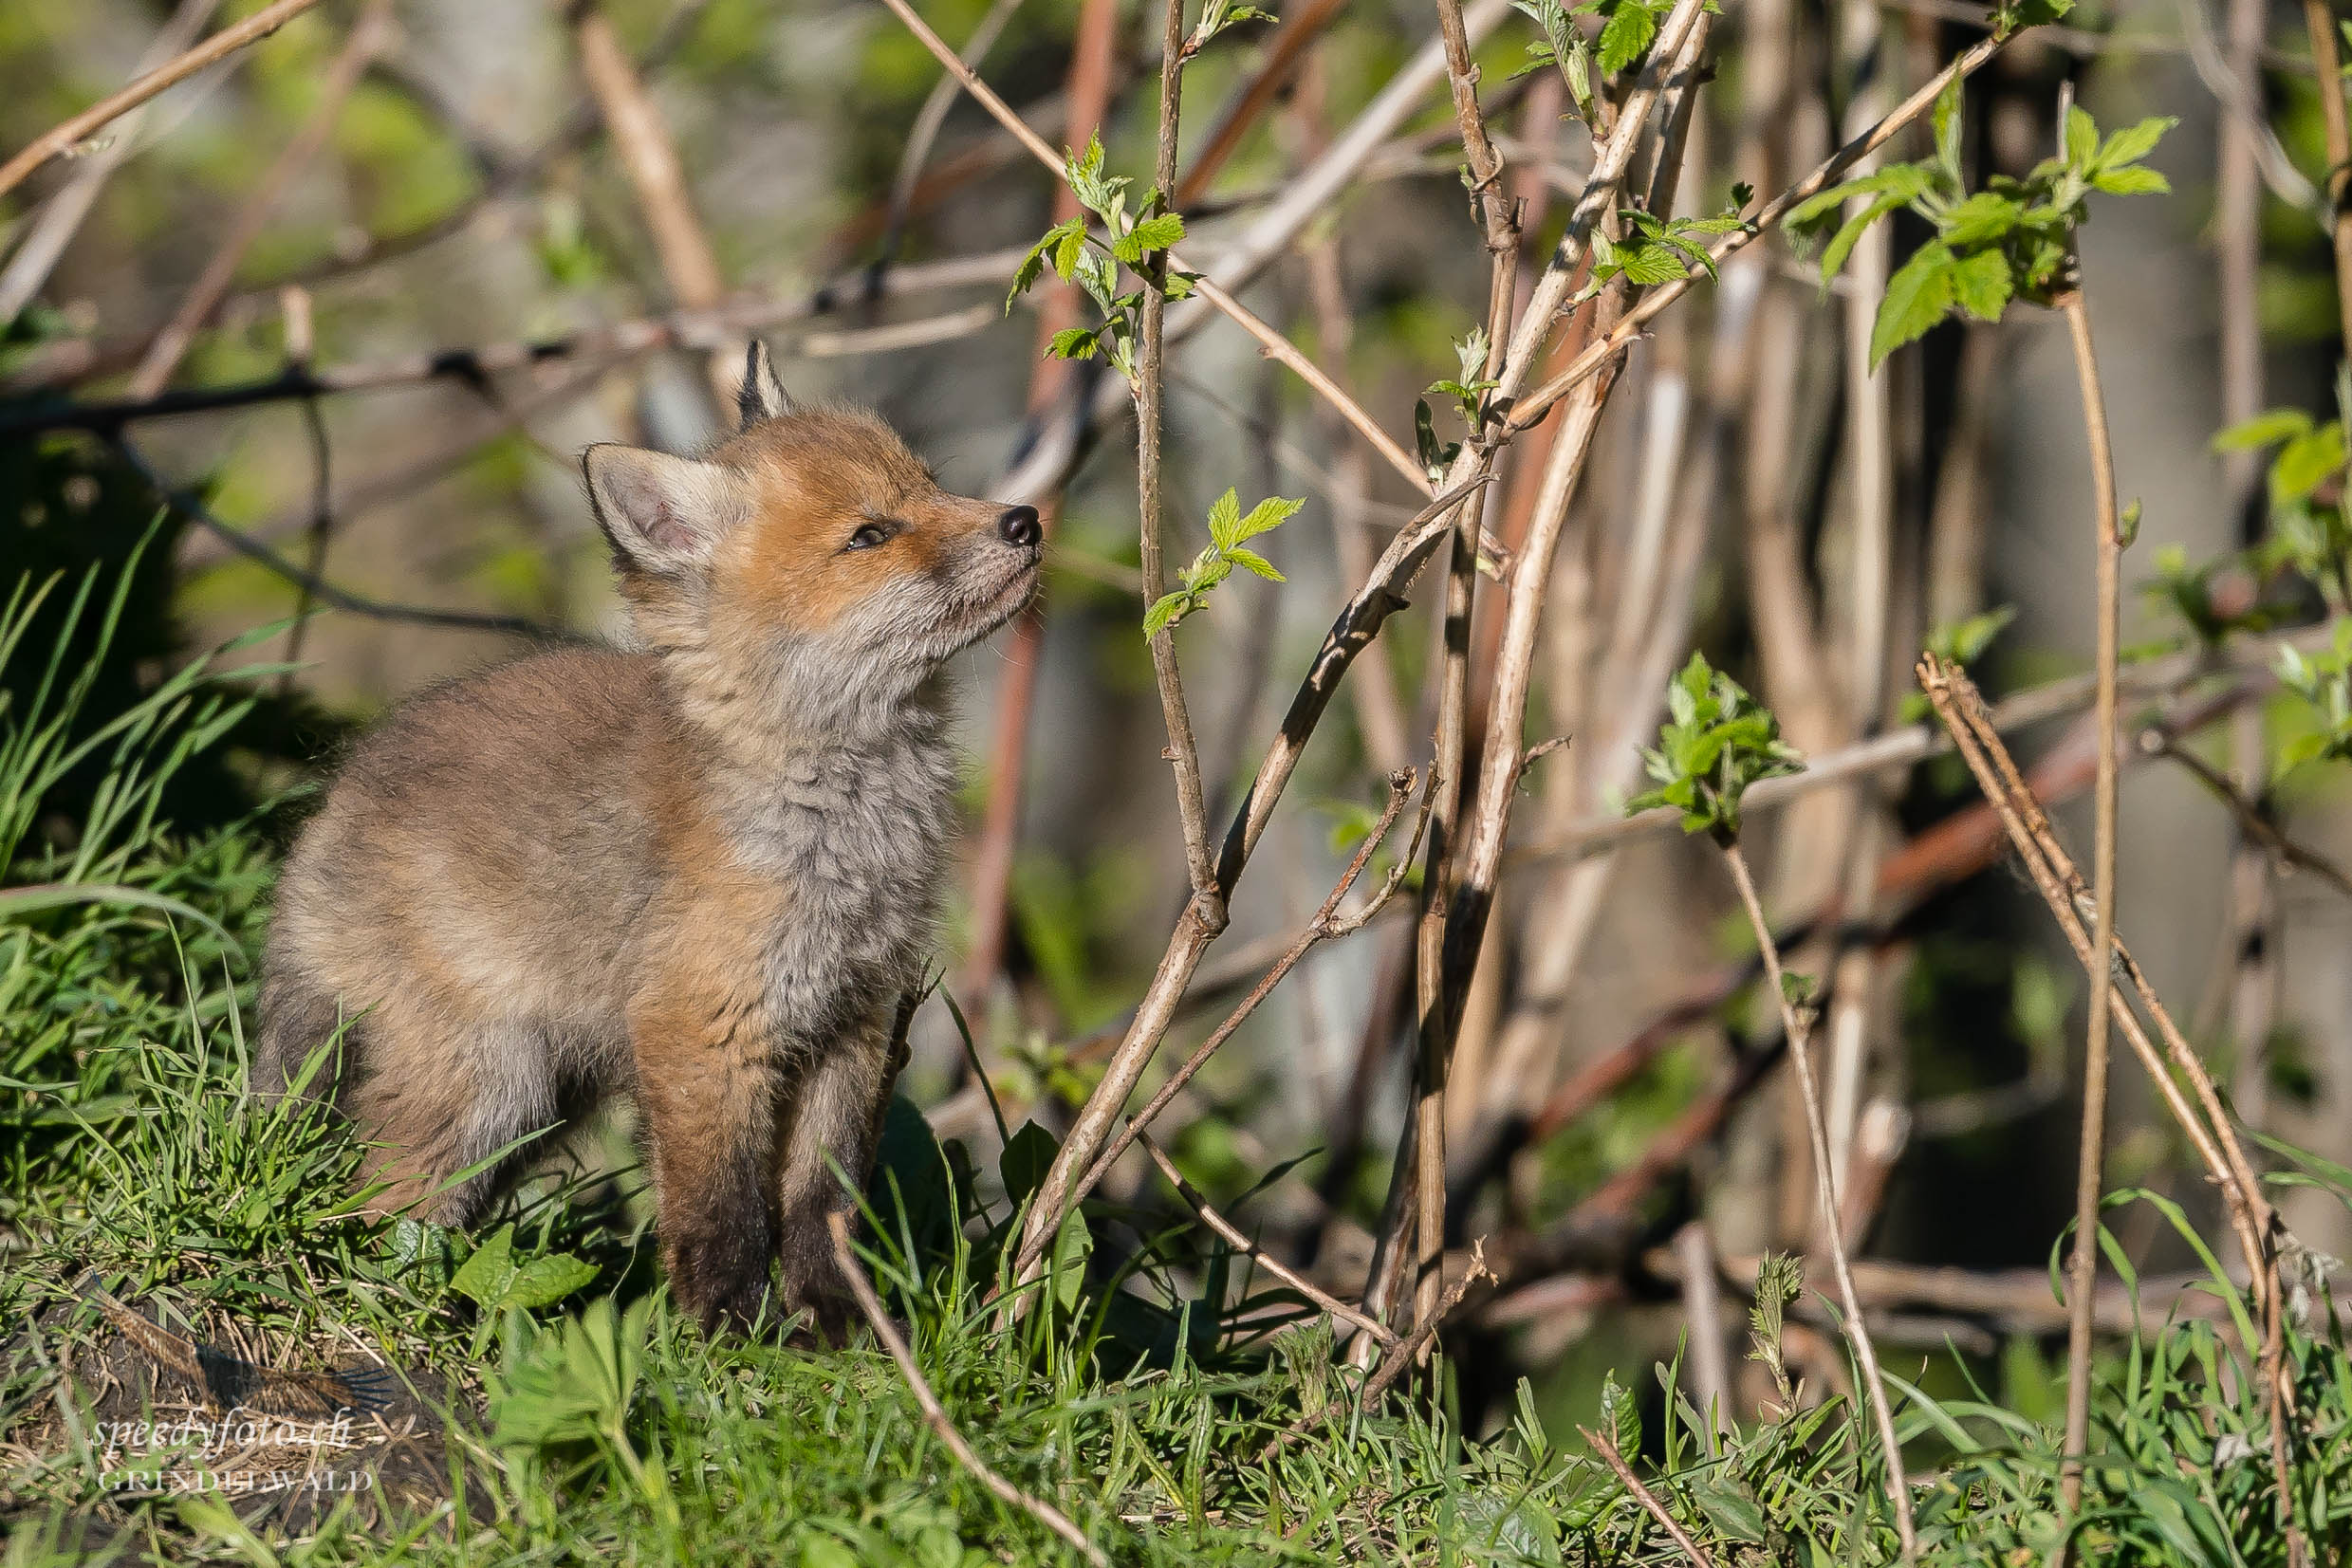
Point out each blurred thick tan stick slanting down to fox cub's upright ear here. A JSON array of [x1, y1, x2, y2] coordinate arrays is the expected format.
[[571, 0, 743, 414]]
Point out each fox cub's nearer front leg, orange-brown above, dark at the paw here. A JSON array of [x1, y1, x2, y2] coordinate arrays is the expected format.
[[630, 968, 779, 1328]]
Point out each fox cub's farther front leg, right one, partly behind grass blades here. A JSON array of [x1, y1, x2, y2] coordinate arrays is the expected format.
[[776, 999, 900, 1342]]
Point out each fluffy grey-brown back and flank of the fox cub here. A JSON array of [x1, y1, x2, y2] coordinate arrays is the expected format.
[[273, 649, 692, 1025]]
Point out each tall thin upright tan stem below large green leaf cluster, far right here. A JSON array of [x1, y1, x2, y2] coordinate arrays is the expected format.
[[2058, 286, 2124, 1512]]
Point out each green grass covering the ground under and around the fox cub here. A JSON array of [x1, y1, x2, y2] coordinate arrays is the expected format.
[[13, 557, 2352, 1568]]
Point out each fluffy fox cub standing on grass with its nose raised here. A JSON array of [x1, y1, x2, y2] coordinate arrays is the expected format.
[[254, 343, 1040, 1336]]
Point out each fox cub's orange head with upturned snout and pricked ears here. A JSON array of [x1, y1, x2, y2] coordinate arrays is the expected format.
[[581, 341, 1040, 724]]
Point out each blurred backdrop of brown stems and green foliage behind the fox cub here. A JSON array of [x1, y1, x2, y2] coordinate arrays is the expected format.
[[0, 0, 2352, 1438]]
